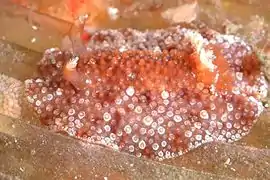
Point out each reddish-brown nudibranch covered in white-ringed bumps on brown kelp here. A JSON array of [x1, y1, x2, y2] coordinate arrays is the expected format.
[[26, 24, 268, 160]]
